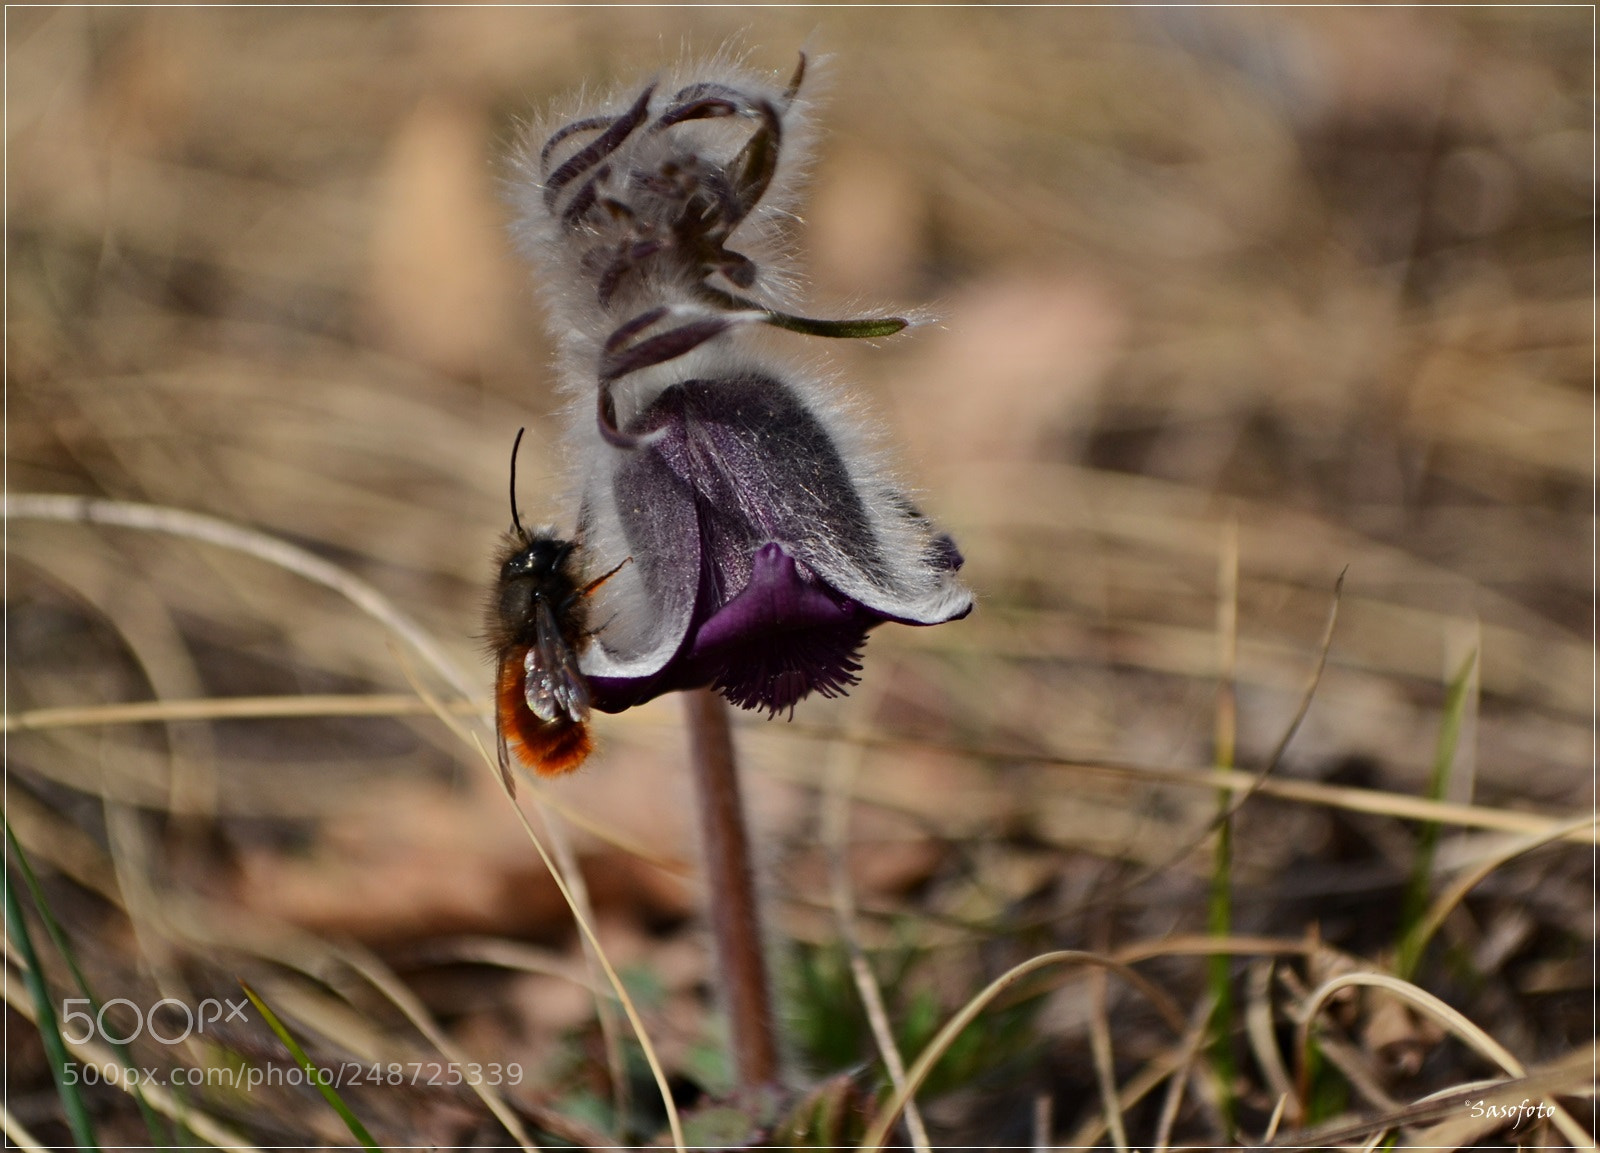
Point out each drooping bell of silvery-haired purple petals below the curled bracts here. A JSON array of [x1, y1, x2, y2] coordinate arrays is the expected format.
[[584, 371, 971, 713]]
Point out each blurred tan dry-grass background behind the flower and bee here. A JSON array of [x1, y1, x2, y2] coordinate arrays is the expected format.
[[6, 8, 1594, 1143]]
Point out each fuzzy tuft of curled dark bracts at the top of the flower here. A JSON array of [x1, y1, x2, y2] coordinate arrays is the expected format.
[[514, 58, 810, 345]]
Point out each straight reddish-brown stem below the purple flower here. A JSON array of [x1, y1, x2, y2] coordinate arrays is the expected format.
[[683, 689, 778, 1086]]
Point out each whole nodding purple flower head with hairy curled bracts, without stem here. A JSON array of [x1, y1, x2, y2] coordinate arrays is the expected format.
[[517, 58, 971, 713]]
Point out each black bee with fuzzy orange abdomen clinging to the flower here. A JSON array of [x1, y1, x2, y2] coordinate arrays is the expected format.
[[485, 429, 632, 790]]
